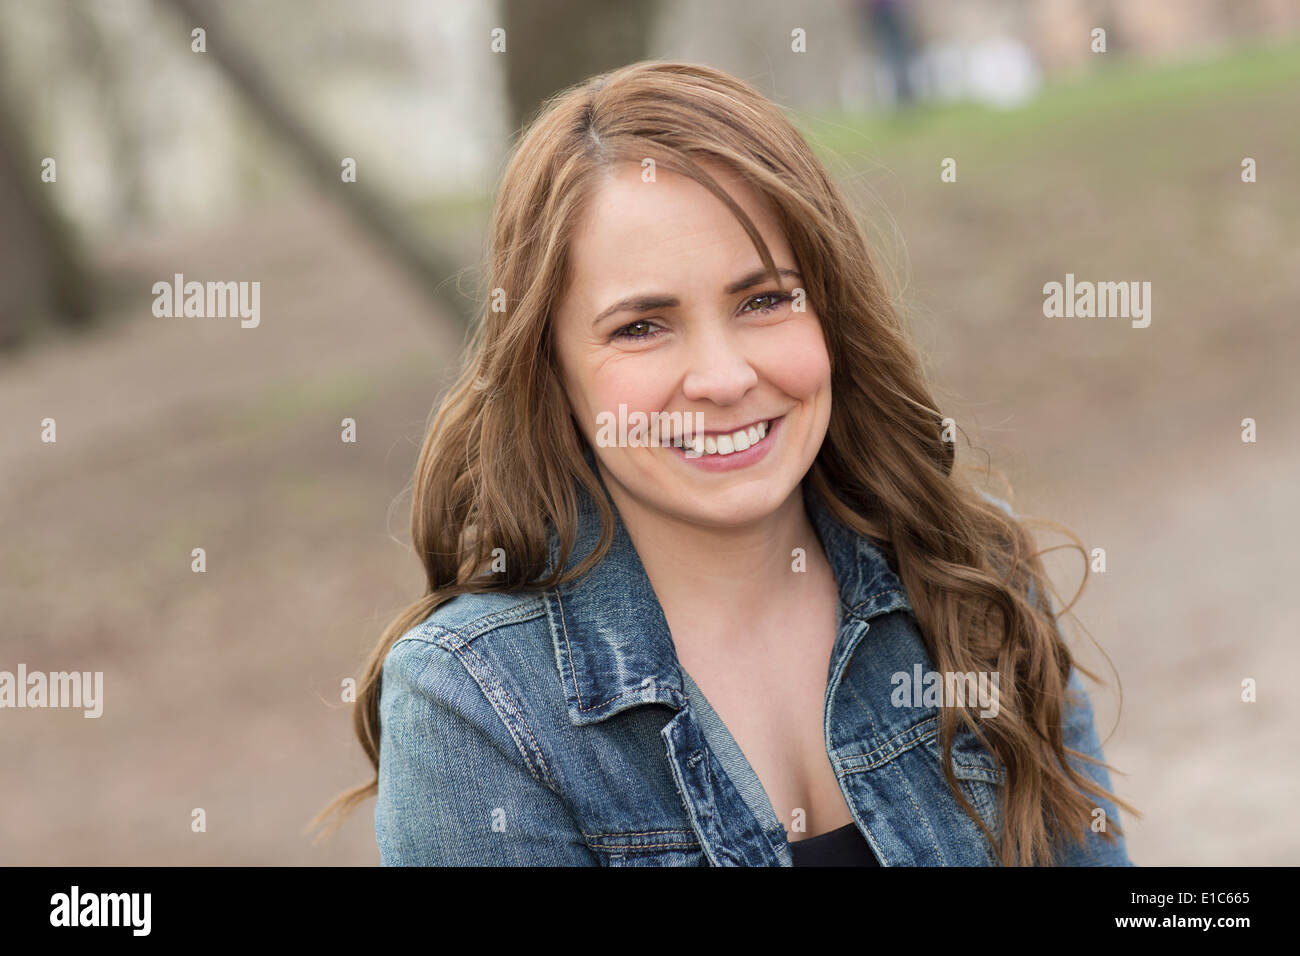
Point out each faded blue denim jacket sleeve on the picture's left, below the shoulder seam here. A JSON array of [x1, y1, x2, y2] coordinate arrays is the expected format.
[[374, 639, 599, 866]]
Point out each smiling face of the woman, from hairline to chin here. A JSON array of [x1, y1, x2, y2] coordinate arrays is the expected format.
[[554, 163, 831, 527]]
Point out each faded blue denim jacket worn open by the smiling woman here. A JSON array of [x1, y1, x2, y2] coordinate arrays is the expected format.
[[374, 450, 1132, 866]]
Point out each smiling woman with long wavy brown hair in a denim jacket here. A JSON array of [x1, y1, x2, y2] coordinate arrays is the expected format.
[[312, 62, 1132, 866]]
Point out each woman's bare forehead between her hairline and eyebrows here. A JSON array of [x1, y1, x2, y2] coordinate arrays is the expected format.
[[569, 163, 789, 294]]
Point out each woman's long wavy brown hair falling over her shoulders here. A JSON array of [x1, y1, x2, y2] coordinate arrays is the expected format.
[[311, 61, 1136, 865]]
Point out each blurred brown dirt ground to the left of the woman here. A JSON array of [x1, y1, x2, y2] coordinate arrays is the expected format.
[[0, 191, 459, 864]]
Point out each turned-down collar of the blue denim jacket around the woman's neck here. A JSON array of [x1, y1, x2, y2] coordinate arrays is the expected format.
[[546, 447, 911, 724]]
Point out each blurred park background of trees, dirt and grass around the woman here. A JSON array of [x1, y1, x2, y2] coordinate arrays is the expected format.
[[0, 0, 1300, 865]]
